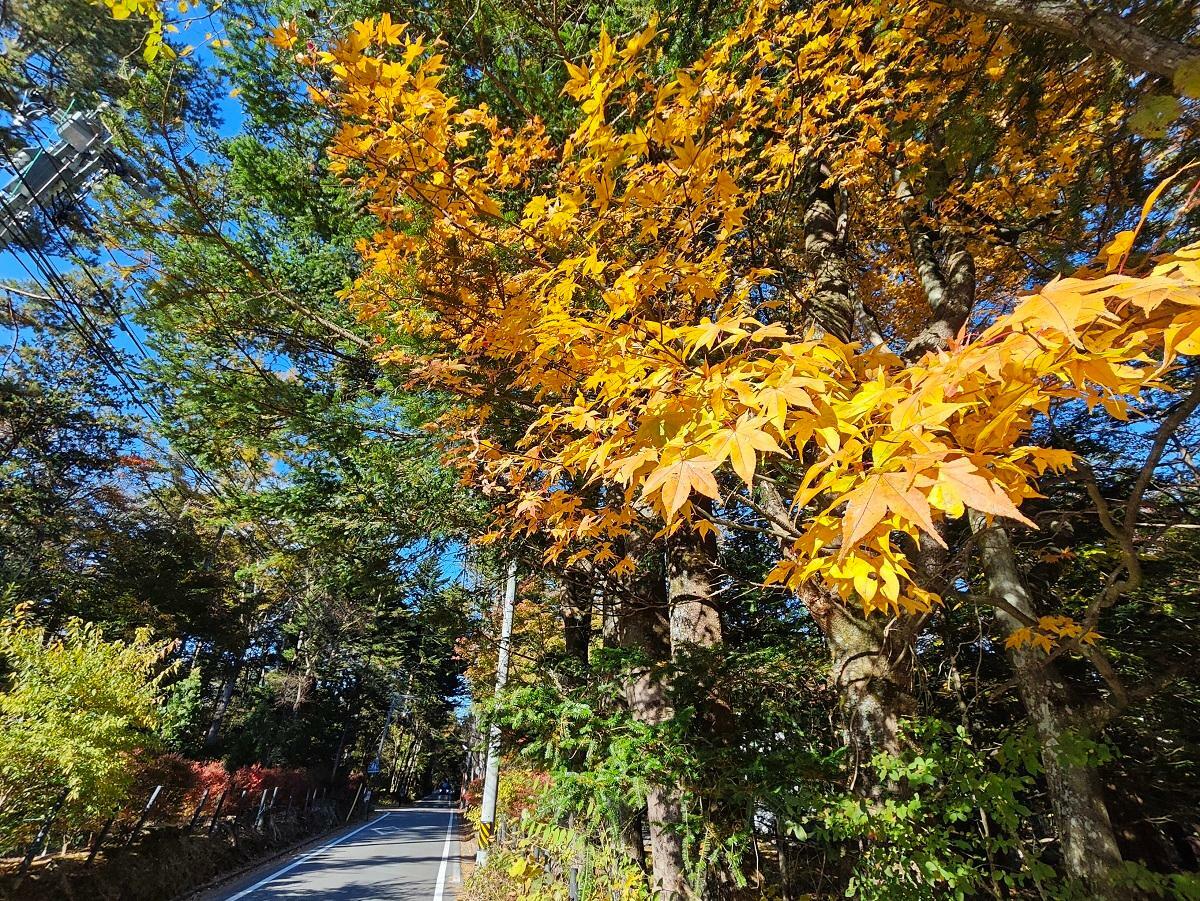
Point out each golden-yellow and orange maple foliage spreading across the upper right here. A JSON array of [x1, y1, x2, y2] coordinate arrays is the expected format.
[[307, 0, 1200, 641]]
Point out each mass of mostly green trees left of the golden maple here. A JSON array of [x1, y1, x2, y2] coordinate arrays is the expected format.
[[0, 0, 476, 853]]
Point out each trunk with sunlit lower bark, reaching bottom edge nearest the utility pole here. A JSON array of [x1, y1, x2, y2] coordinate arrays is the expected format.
[[619, 579, 692, 901]]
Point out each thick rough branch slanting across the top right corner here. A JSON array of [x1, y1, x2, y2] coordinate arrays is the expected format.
[[941, 0, 1200, 78]]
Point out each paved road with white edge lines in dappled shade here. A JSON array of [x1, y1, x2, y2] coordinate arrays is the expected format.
[[220, 805, 460, 901]]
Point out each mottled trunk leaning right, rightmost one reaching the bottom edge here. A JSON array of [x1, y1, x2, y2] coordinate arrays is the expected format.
[[971, 511, 1128, 901]]
